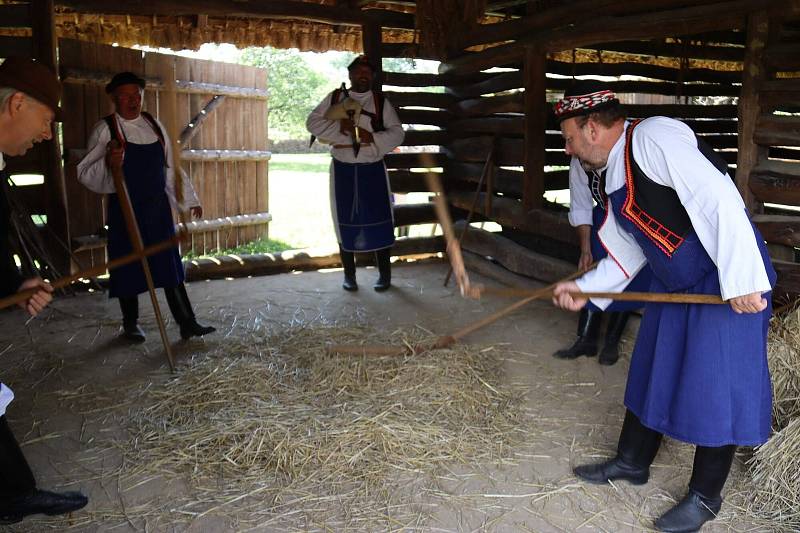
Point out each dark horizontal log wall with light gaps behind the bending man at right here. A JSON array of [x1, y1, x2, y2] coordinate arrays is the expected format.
[[440, 0, 800, 292]]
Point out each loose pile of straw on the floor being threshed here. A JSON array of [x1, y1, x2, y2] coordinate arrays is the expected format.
[[109, 327, 529, 529]]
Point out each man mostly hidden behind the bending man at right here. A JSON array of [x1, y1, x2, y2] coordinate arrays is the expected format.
[[553, 143, 650, 365]]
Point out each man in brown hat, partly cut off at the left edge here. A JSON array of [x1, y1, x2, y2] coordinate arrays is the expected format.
[[0, 57, 88, 524]]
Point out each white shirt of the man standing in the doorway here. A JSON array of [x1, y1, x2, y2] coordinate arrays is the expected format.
[[306, 90, 405, 163]]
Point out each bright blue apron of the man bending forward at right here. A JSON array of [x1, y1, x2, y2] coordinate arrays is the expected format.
[[609, 186, 776, 446]]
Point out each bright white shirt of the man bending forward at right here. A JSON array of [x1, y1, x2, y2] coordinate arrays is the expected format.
[[577, 117, 772, 308]]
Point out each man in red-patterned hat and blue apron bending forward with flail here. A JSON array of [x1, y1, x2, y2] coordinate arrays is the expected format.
[[553, 80, 776, 532]]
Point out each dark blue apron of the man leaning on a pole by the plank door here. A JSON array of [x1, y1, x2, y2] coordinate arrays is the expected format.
[[107, 141, 184, 298]]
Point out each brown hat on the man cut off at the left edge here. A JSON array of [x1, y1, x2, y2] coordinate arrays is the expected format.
[[0, 57, 61, 120]]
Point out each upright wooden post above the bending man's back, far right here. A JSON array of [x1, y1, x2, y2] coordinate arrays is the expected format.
[[736, 11, 769, 213]]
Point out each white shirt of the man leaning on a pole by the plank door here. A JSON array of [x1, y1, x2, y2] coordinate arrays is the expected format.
[[78, 114, 200, 212]]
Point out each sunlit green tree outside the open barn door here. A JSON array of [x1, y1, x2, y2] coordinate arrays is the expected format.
[[240, 47, 331, 139]]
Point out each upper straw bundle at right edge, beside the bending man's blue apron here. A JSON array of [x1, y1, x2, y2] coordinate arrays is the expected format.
[[767, 308, 800, 429]]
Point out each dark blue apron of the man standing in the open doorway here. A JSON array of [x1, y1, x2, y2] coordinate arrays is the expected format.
[[332, 159, 394, 252]]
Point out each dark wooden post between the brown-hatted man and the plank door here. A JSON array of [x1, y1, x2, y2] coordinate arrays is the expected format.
[[31, 0, 72, 273]]
